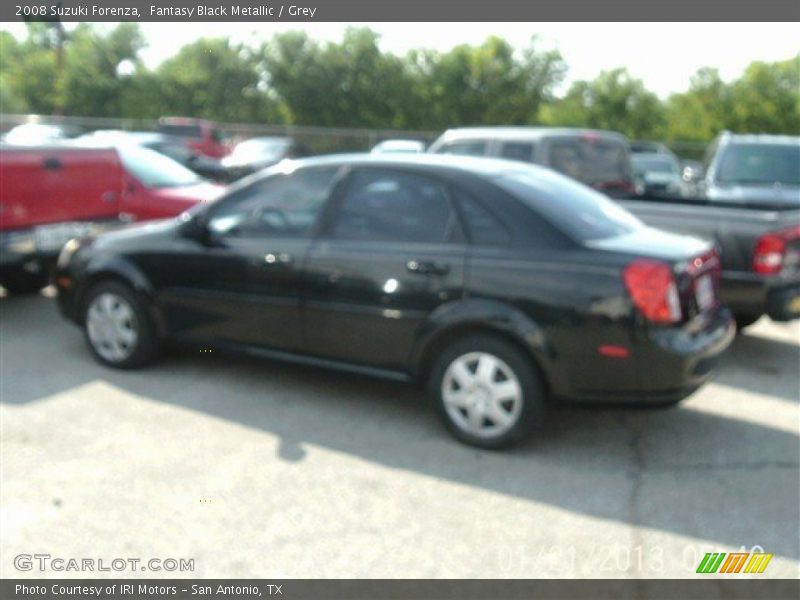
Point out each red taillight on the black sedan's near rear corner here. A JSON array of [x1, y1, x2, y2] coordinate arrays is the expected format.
[[622, 259, 682, 323]]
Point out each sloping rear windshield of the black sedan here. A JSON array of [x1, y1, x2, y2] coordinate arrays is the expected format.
[[495, 167, 644, 242]]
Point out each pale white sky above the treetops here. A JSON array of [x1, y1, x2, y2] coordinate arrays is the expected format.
[[0, 22, 800, 98]]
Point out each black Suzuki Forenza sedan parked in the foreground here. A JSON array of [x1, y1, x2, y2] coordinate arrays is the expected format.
[[55, 154, 734, 447]]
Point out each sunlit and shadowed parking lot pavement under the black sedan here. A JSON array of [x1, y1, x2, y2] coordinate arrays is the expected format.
[[0, 294, 800, 578]]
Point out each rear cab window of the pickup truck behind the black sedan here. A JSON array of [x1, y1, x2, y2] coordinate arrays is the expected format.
[[547, 135, 631, 185]]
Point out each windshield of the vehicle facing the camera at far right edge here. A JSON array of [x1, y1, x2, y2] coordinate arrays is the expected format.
[[716, 143, 800, 185]]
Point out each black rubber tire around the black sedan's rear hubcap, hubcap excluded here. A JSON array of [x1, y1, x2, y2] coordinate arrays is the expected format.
[[427, 334, 546, 449]]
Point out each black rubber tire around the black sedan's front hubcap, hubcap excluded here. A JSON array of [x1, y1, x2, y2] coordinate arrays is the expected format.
[[81, 281, 159, 369]]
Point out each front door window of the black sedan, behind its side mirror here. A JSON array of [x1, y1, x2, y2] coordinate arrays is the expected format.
[[208, 167, 338, 238]]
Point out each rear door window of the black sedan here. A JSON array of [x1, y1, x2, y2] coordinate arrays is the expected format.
[[332, 169, 459, 243]]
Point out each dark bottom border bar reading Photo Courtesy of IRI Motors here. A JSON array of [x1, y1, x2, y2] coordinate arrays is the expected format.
[[0, 575, 800, 600]]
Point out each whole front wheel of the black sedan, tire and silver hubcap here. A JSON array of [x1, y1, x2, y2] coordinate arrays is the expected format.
[[83, 281, 158, 369]]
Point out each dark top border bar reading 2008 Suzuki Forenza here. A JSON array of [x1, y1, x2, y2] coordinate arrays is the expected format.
[[0, 0, 800, 22]]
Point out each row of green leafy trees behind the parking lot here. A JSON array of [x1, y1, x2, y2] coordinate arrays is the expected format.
[[0, 23, 800, 142]]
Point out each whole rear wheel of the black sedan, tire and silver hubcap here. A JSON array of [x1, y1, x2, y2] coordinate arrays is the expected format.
[[428, 335, 544, 448]]
